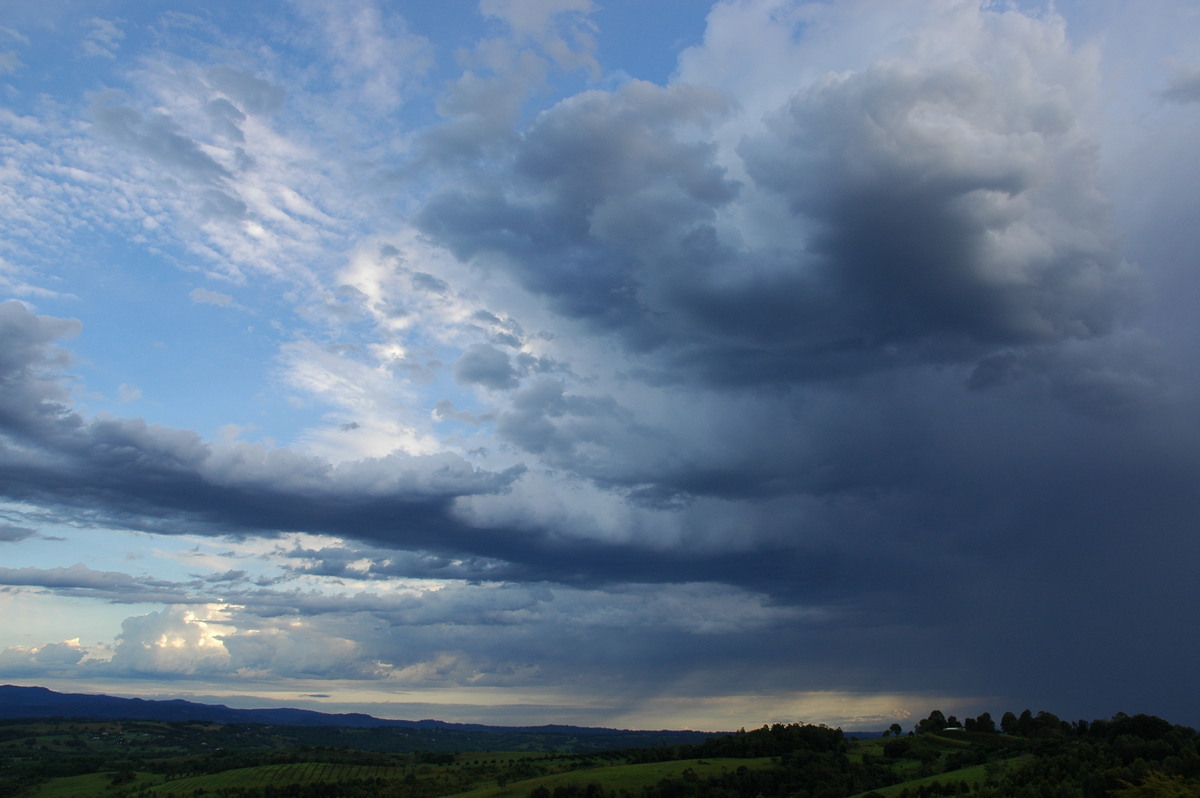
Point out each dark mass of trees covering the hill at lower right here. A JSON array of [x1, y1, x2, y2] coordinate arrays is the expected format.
[[552, 710, 1200, 798]]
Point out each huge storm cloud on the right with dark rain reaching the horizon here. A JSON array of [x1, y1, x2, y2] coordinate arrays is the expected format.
[[403, 24, 1200, 715]]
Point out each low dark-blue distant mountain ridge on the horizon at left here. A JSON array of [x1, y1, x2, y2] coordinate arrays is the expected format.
[[0, 684, 714, 742]]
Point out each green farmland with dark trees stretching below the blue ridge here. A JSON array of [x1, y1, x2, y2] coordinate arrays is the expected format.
[[0, 713, 1200, 798]]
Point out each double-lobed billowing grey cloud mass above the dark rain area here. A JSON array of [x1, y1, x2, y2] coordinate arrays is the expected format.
[[419, 55, 1140, 385]]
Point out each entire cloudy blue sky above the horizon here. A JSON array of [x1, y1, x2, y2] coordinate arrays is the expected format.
[[0, 0, 1200, 731]]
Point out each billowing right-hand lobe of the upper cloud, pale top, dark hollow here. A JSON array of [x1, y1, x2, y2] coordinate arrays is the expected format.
[[743, 66, 1135, 347]]
